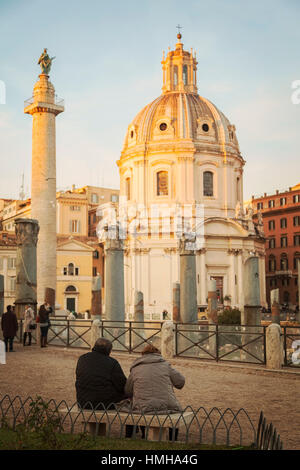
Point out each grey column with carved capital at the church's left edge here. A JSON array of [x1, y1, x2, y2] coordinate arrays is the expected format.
[[105, 235, 125, 322]]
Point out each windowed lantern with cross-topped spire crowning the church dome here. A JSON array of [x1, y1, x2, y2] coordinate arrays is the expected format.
[[161, 33, 197, 94]]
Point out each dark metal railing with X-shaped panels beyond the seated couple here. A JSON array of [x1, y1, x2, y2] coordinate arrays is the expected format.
[[11, 317, 300, 367]]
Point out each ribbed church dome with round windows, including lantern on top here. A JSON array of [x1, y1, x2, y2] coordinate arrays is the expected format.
[[122, 36, 240, 156]]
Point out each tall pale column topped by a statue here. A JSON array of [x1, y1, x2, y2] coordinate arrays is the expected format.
[[24, 49, 64, 306]]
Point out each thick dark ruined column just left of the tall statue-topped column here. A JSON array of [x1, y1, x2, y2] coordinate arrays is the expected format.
[[15, 218, 39, 318]]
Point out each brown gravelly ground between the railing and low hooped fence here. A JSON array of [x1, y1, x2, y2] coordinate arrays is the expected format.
[[0, 343, 300, 450]]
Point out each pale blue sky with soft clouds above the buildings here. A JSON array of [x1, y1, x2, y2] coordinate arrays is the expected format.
[[0, 0, 300, 199]]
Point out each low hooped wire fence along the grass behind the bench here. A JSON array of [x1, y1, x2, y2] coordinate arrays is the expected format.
[[0, 395, 282, 450]]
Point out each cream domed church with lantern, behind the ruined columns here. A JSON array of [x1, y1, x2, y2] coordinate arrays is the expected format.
[[100, 34, 266, 319]]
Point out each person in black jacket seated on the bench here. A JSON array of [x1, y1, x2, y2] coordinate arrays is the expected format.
[[75, 338, 126, 409]]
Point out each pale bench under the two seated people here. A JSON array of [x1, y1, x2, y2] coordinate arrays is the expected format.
[[59, 407, 194, 441]]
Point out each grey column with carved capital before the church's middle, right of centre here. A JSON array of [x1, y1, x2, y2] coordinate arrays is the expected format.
[[179, 238, 198, 323]]
